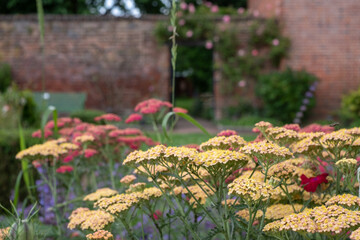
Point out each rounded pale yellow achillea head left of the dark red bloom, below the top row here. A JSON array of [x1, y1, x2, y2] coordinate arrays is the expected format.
[[228, 178, 273, 202]]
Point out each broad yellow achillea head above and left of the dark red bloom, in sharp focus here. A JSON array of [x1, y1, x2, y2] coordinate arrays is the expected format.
[[240, 141, 292, 162]]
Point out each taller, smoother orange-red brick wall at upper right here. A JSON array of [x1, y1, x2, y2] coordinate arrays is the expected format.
[[249, 0, 360, 117]]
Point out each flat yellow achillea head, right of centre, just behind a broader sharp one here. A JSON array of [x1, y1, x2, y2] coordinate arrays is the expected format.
[[200, 135, 246, 151]]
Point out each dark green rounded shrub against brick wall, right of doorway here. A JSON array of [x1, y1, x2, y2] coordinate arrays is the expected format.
[[256, 68, 316, 123]]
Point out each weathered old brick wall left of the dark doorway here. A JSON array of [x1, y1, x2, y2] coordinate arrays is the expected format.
[[0, 16, 170, 113]]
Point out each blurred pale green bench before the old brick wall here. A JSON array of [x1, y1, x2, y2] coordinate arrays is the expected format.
[[33, 92, 86, 113]]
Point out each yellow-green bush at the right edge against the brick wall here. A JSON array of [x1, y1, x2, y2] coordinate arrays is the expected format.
[[339, 88, 360, 124]]
